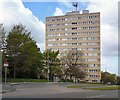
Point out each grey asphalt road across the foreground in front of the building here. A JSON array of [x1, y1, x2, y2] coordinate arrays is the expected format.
[[2, 83, 118, 98]]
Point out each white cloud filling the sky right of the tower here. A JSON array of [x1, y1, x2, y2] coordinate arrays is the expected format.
[[86, 0, 118, 74]]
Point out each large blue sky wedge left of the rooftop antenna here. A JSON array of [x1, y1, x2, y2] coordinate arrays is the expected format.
[[24, 2, 59, 23]]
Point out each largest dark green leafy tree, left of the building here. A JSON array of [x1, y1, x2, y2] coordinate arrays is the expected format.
[[6, 24, 43, 78]]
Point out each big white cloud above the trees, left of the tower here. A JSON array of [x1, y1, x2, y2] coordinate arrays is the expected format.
[[0, 0, 45, 50]]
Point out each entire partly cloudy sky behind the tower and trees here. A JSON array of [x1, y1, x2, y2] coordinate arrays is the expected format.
[[0, 0, 120, 75]]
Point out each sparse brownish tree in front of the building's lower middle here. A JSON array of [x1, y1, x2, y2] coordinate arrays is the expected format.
[[62, 50, 87, 80]]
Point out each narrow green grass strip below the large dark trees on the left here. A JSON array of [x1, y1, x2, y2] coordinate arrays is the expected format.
[[7, 78, 51, 82]]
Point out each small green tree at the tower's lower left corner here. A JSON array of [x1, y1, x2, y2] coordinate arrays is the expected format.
[[43, 50, 62, 80]]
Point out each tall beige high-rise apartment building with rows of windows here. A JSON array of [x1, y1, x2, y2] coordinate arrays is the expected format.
[[46, 10, 101, 82]]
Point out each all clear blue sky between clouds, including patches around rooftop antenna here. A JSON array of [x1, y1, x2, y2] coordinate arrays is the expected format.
[[23, 2, 89, 23]]
